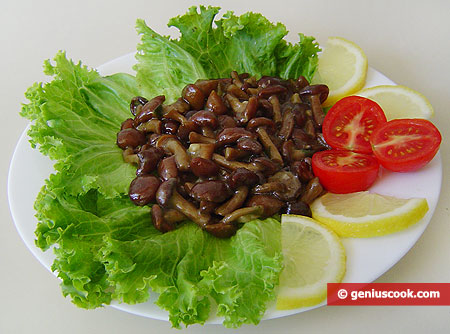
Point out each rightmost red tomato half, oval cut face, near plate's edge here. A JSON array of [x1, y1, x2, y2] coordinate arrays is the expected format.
[[370, 119, 442, 172]]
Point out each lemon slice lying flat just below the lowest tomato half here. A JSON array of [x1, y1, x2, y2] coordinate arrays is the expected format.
[[311, 191, 428, 238]]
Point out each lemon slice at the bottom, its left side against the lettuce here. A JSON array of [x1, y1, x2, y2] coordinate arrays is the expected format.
[[276, 215, 346, 310]]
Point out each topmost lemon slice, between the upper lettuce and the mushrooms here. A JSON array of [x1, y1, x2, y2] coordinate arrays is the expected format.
[[312, 37, 367, 107]]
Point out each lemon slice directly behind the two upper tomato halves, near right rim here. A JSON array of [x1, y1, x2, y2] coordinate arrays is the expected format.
[[355, 85, 434, 120]]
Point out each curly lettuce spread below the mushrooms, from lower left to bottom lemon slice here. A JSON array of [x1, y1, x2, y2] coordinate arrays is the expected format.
[[36, 173, 282, 327]]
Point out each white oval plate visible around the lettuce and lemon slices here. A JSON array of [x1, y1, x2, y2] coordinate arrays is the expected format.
[[8, 54, 442, 323]]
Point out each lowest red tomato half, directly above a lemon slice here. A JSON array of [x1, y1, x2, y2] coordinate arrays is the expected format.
[[312, 150, 380, 194]]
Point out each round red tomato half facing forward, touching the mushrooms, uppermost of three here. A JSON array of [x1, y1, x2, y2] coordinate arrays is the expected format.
[[322, 96, 386, 153]]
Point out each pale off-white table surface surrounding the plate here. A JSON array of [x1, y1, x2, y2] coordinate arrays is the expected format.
[[0, 0, 450, 334]]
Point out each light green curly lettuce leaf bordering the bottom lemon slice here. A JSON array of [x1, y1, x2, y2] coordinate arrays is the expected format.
[[201, 218, 282, 327]]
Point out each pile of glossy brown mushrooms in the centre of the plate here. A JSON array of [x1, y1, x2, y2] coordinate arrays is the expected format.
[[117, 71, 329, 238]]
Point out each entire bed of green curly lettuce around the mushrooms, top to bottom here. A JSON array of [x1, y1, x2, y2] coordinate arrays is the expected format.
[[21, 6, 319, 327]]
